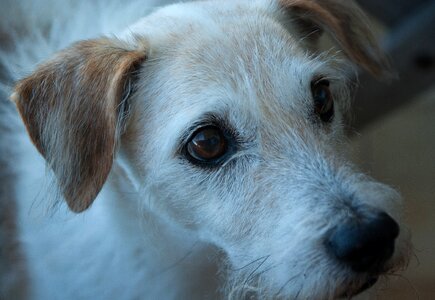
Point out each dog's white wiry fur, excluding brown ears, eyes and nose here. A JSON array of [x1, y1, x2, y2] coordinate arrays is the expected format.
[[0, 0, 408, 299]]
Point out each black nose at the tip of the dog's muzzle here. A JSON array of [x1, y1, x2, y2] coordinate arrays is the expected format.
[[326, 212, 399, 272]]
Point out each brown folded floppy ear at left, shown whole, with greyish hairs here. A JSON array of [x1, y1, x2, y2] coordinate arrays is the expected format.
[[11, 38, 146, 212]]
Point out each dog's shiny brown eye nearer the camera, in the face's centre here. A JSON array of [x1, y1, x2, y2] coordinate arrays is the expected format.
[[186, 126, 228, 163]]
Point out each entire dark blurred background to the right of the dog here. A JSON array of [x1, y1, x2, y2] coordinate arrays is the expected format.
[[352, 0, 435, 300]]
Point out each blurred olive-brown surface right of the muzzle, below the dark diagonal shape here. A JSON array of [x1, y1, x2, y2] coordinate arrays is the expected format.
[[353, 88, 435, 300]]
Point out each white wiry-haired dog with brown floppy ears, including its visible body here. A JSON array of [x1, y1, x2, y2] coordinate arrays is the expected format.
[[0, 0, 411, 299]]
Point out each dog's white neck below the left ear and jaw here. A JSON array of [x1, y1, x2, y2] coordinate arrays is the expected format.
[[19, 151, 219, 299]]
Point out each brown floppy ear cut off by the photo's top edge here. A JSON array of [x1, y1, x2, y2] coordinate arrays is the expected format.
[[279, 0, 391, 77]]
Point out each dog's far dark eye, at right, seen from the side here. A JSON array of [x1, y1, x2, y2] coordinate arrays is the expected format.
[[311, 80, 334, 123]]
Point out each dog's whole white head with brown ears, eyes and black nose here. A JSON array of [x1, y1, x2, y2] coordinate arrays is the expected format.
[[13, 0, 408, 299]]
